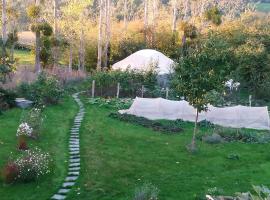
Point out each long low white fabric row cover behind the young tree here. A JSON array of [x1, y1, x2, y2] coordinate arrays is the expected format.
[[119, 97, 270, 130]]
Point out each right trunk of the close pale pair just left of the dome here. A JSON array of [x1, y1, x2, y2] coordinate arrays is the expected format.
[[104, 0, 111, 68]]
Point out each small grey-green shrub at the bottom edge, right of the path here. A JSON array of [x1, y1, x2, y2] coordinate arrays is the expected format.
[[133, 183, 159, 200]]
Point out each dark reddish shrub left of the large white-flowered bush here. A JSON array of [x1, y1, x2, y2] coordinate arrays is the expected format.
[[3, 162, 19, 184]]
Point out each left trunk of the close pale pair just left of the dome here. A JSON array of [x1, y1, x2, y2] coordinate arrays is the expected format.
[[97, 0, 103, 71]]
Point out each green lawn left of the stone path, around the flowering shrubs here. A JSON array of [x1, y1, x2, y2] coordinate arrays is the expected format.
[[0, 97, 77, 200]]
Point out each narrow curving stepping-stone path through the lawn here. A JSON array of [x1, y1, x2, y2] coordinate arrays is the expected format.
[[51, 93, 85, 200]]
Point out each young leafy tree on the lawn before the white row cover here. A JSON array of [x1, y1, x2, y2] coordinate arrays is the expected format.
[[173, 35, 232, 152]]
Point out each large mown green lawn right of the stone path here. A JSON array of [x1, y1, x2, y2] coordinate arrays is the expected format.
[[68, 96, 270, 200]]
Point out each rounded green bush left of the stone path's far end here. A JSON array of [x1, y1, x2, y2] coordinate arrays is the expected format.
[[18, 73, 64, 105]]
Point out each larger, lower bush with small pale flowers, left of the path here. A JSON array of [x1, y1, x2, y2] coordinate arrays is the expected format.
[[14, 148, 51, 182]]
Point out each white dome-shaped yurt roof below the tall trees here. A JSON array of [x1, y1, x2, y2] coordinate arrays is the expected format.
[[112, 49, 174, 75]]
